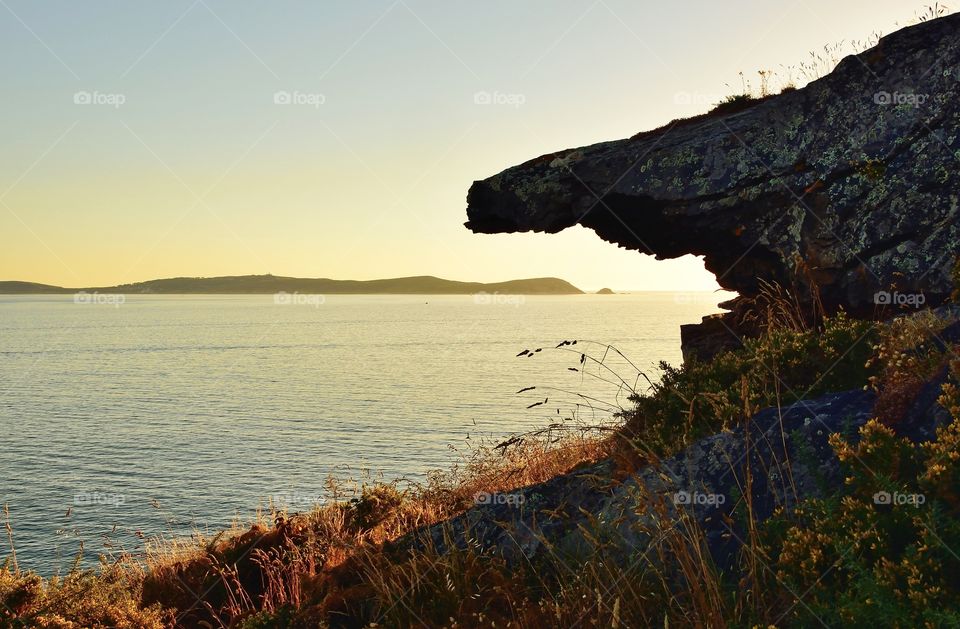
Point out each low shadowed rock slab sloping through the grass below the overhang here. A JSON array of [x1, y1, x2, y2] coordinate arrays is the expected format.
[[394, 364, 953, 571]]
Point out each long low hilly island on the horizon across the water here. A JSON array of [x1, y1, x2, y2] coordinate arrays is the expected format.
[[0, 275, 583, 295]]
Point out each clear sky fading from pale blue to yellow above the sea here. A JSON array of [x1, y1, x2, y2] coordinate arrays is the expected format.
[[0, 0, 929, 290]]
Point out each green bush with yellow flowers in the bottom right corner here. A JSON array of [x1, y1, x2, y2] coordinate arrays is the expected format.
[[762, 366, 960, 627]]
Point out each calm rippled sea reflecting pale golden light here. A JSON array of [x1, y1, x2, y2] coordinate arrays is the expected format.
[[0, 293, 724, 574]]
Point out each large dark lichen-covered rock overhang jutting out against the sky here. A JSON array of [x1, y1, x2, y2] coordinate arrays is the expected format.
[[466, 15, 960, 355]]
